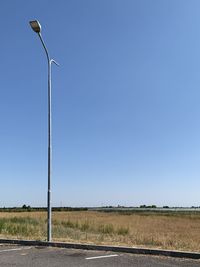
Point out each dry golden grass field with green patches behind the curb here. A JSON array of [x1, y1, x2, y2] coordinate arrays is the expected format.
[[0, 211, 200, 252]]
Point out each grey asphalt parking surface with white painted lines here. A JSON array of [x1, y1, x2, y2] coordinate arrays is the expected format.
[[0, 245, 200, 267]]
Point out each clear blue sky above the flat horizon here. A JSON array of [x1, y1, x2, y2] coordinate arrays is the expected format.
[[0, 0, 200, 206]]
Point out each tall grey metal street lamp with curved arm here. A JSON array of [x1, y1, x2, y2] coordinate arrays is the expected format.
[[30, 20, 59, 242]]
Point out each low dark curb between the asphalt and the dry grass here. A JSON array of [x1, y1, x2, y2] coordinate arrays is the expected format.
[[0, 239, 200, 259]]
